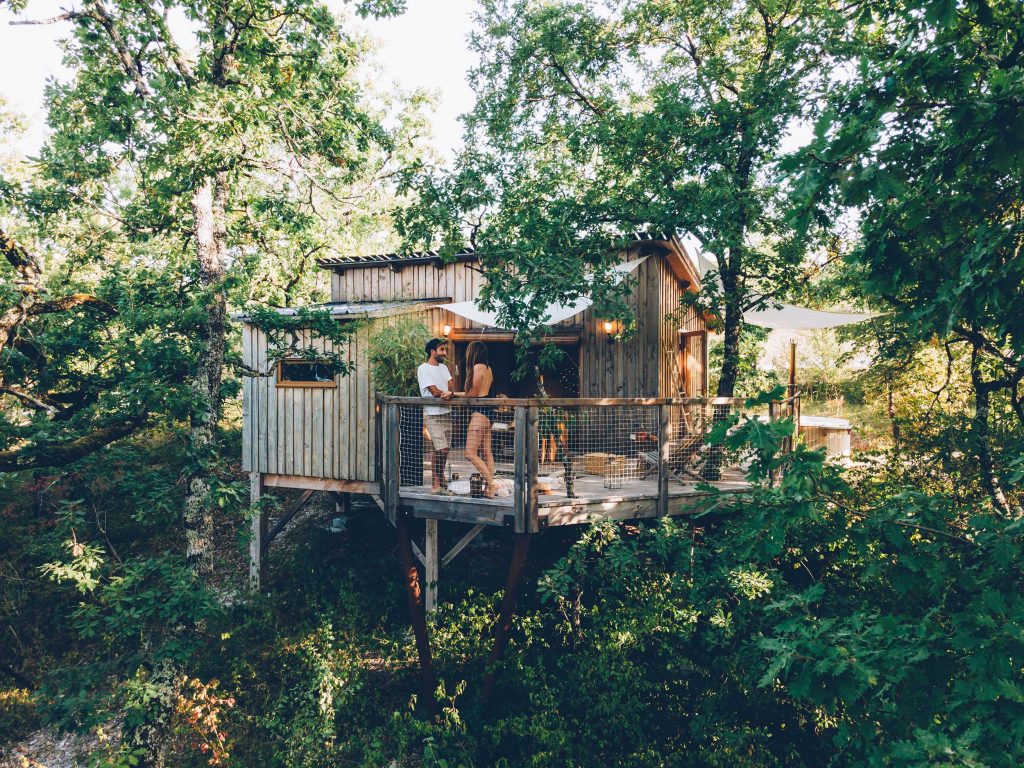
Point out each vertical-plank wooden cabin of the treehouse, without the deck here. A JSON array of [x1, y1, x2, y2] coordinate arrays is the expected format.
[[242, 236, 708, 493]]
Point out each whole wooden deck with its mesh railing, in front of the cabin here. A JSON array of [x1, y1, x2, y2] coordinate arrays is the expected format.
[[380, 394, 799, 532]]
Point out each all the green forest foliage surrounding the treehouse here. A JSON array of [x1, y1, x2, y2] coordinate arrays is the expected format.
[[0, 0, 1024, 768]]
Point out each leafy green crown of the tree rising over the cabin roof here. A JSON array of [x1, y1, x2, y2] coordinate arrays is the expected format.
[[398, 0, 851, 395]]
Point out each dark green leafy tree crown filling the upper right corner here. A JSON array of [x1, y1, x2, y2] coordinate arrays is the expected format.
[[788, 0, 1024, 515]]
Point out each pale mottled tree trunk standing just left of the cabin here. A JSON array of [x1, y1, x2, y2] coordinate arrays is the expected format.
[[184, 172, 227, 572]]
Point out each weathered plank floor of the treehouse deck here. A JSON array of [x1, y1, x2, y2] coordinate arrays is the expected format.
[[399, 457, 749, 527]]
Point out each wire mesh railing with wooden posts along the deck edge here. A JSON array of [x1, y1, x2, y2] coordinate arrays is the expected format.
[[381, 394, 800, 529]]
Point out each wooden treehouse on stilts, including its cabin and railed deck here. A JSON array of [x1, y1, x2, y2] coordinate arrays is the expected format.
[[242, 236, 798, 608]]
